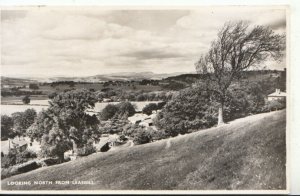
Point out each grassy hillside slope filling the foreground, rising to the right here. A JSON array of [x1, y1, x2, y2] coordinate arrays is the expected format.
[[2, 110, 286, 190]]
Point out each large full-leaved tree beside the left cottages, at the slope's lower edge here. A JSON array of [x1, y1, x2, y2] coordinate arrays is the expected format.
[[27, 89, 100, 161]]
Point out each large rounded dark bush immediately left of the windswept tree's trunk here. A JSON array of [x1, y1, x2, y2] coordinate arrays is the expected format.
[[154, 88, 218, 136]]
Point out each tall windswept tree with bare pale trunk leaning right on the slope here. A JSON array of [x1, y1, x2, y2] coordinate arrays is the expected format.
[[196, 21, 285, 124]]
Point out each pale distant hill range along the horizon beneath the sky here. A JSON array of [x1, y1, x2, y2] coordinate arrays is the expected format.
[[1, 72, 193, 84]]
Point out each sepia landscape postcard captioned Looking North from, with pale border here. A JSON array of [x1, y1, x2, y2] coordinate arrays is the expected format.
[[1, 6, 289, 193]]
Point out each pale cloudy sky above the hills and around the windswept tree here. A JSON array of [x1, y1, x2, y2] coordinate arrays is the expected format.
[[1, 6, 286, 77]]
